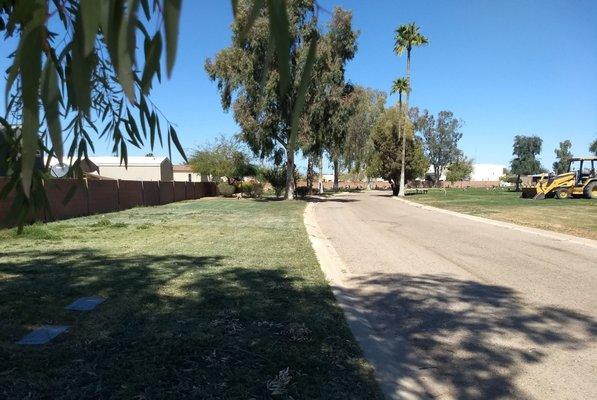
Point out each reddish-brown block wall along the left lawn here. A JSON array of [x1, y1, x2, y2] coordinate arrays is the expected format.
[[0, 178, 217, 227]]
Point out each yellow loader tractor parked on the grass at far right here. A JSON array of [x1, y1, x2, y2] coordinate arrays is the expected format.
[[529, 157, 597, 200]]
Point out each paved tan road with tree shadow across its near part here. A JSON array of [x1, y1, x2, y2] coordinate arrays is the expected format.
[[307, 193, 597, 399]]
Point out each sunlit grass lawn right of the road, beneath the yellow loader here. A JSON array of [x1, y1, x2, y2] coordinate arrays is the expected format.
[[408, 189, 597, 239]]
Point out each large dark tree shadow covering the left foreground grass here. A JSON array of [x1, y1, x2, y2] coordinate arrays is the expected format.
[[0, 249, 380, 399]]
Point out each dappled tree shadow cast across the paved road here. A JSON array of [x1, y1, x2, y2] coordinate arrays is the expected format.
[[342, 274, 597, 399]]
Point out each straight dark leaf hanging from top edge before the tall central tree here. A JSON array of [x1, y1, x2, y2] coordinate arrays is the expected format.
[[267, 0, 290, 101]]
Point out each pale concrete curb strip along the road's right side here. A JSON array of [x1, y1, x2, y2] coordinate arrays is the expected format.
[[392, 196, 597, 249]]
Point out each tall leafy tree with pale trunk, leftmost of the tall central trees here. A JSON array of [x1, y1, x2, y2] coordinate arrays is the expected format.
[[205, 0, 328, 198]]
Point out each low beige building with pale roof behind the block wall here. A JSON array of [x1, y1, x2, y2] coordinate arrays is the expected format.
[[89, 157, 174, 181]]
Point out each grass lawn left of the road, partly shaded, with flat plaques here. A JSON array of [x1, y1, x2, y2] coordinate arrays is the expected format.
[[0, 199, 380, 399]]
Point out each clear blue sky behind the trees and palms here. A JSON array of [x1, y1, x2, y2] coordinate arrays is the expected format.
[[0, 0, 597, 171]]
